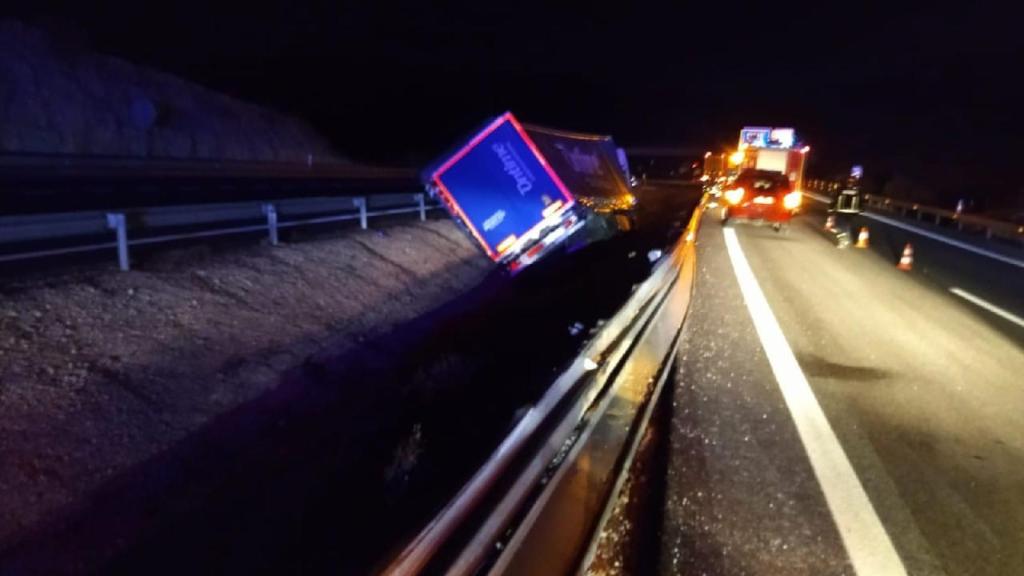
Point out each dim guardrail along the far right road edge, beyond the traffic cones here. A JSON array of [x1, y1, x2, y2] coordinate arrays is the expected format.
[[808, 180, 1024, 245]]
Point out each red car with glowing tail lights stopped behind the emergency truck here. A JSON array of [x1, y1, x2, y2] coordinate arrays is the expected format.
[[722, 169, 803, 231]]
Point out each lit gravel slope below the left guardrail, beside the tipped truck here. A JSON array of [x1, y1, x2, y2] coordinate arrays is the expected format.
[[0, 220, 492, 549]]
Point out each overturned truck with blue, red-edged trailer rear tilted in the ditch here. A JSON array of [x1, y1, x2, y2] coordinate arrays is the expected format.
[[423, 113, 635, 272]]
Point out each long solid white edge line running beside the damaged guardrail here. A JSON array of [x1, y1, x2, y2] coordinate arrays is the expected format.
[[723, 228, 906, 576]]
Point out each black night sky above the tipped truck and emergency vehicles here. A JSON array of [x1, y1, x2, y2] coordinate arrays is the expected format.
[[15, 0, 1024, 207]]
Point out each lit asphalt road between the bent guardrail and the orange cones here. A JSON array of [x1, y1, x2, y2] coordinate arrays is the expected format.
[[659, 199, 1024, 576]]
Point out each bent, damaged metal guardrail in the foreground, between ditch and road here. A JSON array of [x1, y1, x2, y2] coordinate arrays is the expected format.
[[384, 194, 706, 575]]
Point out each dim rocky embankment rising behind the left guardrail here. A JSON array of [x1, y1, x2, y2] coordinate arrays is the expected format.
[[0, 20, 336, 162]]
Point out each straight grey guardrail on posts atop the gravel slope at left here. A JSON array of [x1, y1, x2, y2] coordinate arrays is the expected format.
[[0, 194, 439, 271]]
